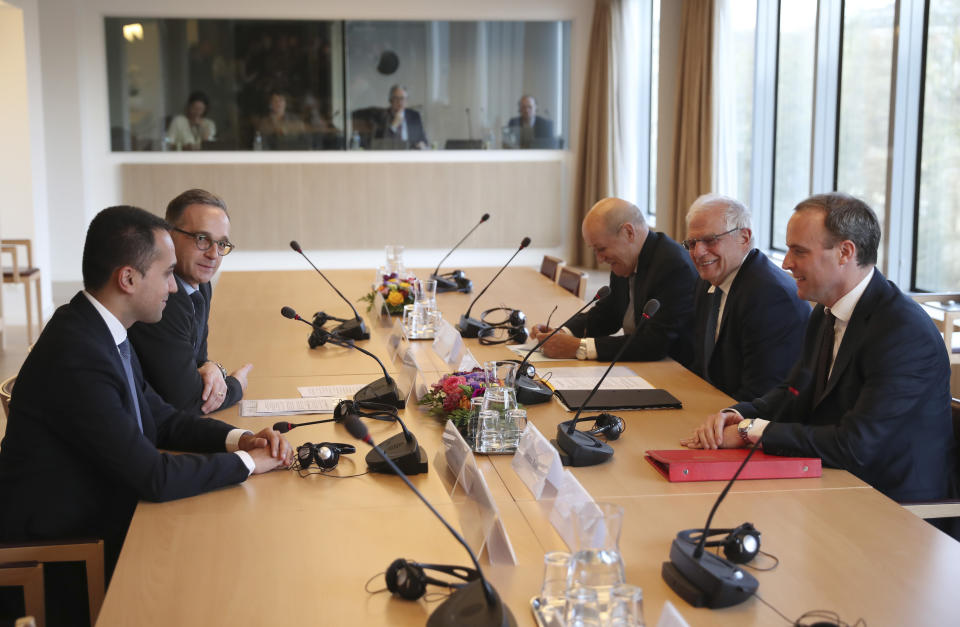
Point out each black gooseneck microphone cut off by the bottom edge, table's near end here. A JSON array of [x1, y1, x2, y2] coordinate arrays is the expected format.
[[343, 415, 517, 627]]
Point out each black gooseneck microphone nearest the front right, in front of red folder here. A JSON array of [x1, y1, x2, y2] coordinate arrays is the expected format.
[[660, 368, 813, 609]]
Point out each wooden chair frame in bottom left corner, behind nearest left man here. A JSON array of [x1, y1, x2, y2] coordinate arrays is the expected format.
[[0, 540, 104, 625]]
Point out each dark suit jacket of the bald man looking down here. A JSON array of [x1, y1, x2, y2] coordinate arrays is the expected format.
[[567, 231, 697, 366]]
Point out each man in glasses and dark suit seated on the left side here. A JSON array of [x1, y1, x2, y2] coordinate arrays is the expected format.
[[130, 189, 253, 414]]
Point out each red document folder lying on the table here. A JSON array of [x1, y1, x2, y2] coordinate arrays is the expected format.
[[646, 448, 822, 481]]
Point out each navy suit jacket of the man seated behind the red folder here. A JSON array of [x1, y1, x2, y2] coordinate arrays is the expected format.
[[735, 270, 956, 501]]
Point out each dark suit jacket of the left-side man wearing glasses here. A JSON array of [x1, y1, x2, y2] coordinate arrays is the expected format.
[[128, 277, 243, 413]]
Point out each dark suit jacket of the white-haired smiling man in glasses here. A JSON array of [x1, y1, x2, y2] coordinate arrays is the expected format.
[[691, 249, 810, 401]]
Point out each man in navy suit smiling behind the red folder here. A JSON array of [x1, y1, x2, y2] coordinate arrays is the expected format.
[[681, 193, 956, 501]]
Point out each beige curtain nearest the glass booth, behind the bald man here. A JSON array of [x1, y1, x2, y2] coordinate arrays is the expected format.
[[570, 0, 621, 268]]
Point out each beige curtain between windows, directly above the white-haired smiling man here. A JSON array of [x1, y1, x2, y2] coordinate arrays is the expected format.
[[661, 0, 714, 239]]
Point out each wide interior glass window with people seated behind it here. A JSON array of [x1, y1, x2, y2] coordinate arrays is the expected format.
[[105, 17, 570, 151]]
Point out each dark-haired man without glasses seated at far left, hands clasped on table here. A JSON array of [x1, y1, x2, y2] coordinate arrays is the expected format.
[[0, 207, 292, 577]]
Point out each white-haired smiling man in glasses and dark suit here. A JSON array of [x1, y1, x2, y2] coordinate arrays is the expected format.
[[683, 194, 810, 401]]
